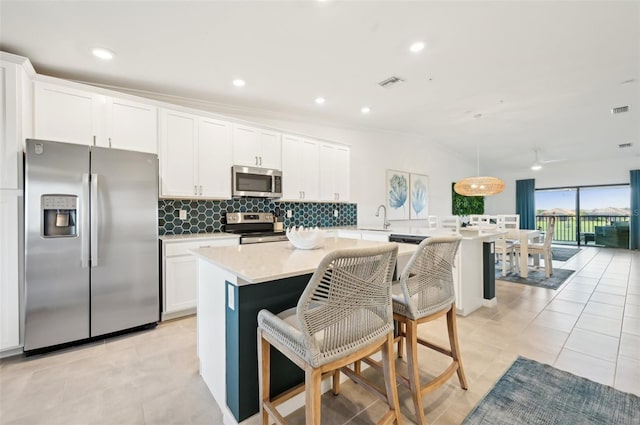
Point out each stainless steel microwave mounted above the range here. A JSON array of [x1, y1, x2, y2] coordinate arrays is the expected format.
[[231, 165, 282, 198]]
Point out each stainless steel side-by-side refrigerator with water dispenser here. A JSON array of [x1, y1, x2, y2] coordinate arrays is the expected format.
[[24, 140, 160, 351]]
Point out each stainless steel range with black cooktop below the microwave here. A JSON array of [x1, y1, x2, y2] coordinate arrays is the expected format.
[[225, 212, 287, 245]]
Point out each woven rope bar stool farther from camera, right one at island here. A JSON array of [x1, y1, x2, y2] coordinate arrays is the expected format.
[[343, 236, 468, 425]]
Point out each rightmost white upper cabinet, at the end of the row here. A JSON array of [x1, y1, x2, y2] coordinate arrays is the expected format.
[[320, 143, 350, 201]]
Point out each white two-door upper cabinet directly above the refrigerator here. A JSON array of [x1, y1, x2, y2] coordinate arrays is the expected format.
[[34, 81, 158, 153]]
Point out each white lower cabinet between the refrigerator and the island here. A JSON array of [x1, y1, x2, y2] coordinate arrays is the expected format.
[[162, 236, 238, 320]]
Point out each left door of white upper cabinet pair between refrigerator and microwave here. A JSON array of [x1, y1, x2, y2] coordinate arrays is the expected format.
[[160, 109, 198, 197]]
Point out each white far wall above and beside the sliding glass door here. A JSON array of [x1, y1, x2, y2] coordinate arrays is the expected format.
[[485, 156, 640, 214]]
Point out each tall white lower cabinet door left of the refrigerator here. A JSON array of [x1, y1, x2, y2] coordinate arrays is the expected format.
[[0, 189, 22, 350]]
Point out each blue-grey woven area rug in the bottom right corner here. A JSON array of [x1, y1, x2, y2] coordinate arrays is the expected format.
[[462, 357, 640, 425]]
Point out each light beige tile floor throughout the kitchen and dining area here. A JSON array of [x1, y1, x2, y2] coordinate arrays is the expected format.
[[0, 247, 640, 425]]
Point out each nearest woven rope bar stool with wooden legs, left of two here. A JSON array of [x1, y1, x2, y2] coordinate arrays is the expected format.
[[258, 244, 401, 425]]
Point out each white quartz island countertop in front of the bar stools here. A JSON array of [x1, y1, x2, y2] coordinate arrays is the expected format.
[[192, 237, 417, 285]]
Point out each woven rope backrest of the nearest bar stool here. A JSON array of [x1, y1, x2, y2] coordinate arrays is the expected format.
[[296, 244, 398, 367]]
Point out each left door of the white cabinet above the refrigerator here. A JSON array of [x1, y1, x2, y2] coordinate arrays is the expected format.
[[34, 82, 106, 145]]
